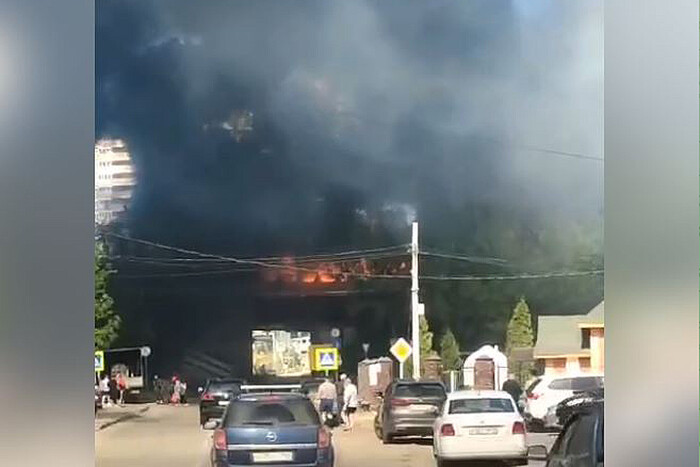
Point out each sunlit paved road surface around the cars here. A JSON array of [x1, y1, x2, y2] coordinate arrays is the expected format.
[[95, 405, 553, 467]]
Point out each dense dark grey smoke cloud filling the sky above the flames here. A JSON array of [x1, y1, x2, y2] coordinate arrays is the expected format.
[[97, 0, 603, 253]]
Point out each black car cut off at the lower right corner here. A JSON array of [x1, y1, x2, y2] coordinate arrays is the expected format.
[[528, 393, 605, 467]]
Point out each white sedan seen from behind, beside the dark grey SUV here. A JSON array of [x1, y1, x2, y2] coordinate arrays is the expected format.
[[433, 391, 527, 466]]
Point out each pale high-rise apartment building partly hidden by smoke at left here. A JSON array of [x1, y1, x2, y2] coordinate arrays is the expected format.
[[95, 139, 136, 225]]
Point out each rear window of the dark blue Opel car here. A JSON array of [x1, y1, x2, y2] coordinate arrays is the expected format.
[[225, 398, 320, 426]]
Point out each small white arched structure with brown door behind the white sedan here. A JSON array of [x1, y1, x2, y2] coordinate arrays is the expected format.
[[462, 345, 508, 390]]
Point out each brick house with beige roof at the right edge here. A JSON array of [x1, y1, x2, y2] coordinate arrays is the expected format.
[[533, 302, 605, 375]]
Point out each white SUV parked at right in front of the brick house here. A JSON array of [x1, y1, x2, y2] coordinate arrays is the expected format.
[[524, 374, 603, 431]]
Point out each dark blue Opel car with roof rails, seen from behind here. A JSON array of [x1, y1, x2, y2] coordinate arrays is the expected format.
[[212, 393, 334, 467]]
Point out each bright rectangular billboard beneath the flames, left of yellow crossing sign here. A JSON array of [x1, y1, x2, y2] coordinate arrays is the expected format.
[[251, 330, 311, 377]]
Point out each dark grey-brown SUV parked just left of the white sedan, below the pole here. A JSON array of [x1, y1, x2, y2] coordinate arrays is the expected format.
[[374, 380, 447, 444]]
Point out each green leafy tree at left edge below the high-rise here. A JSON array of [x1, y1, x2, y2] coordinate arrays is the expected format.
[[95, 241, 121, 349]]
